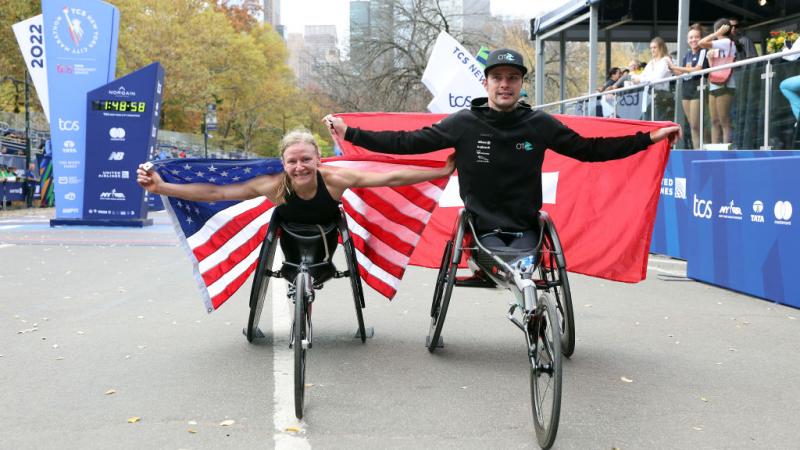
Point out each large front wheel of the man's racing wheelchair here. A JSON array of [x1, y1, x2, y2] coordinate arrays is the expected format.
[[528, 292, 562, 449]]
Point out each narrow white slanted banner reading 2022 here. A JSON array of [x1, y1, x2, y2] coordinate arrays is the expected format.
[[12, 14, 50, 121]]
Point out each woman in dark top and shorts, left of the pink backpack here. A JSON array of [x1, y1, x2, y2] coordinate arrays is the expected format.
[[669, 23, 708, 148]]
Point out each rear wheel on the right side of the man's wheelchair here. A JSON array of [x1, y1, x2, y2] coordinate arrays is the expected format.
[[539, 236, 575, 358]]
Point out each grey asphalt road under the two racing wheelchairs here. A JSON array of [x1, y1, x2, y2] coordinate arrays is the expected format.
[[0, 210, 800, 449]]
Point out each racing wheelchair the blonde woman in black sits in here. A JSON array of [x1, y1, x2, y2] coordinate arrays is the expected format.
[[245, 207, 372, 419]]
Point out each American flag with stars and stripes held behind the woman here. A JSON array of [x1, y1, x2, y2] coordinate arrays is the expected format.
[[154, 155, 447, 312]]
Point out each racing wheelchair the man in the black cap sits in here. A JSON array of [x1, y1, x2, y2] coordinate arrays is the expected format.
[[426, 210, 575, 448]]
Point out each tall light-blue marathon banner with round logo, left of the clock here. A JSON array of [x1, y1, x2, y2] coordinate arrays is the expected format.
[[42, 0, 119, 219]]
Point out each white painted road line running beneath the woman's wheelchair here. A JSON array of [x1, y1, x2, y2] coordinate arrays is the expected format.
[[269, 248, 311, 450]]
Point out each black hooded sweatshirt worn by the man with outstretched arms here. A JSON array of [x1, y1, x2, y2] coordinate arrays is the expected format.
[[345, 97, 653, 232]]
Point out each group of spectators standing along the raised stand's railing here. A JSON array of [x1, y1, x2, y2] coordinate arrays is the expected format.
[[598, 19, 800, 148]]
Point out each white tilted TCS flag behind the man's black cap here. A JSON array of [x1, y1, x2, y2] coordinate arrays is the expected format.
[[422, 31, 486, 114]]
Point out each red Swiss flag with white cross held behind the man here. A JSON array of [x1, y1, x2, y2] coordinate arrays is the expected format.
[[336, 113, 672, 283]]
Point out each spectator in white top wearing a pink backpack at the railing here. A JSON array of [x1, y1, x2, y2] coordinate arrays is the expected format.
[[697, 19, 736, 144]]
